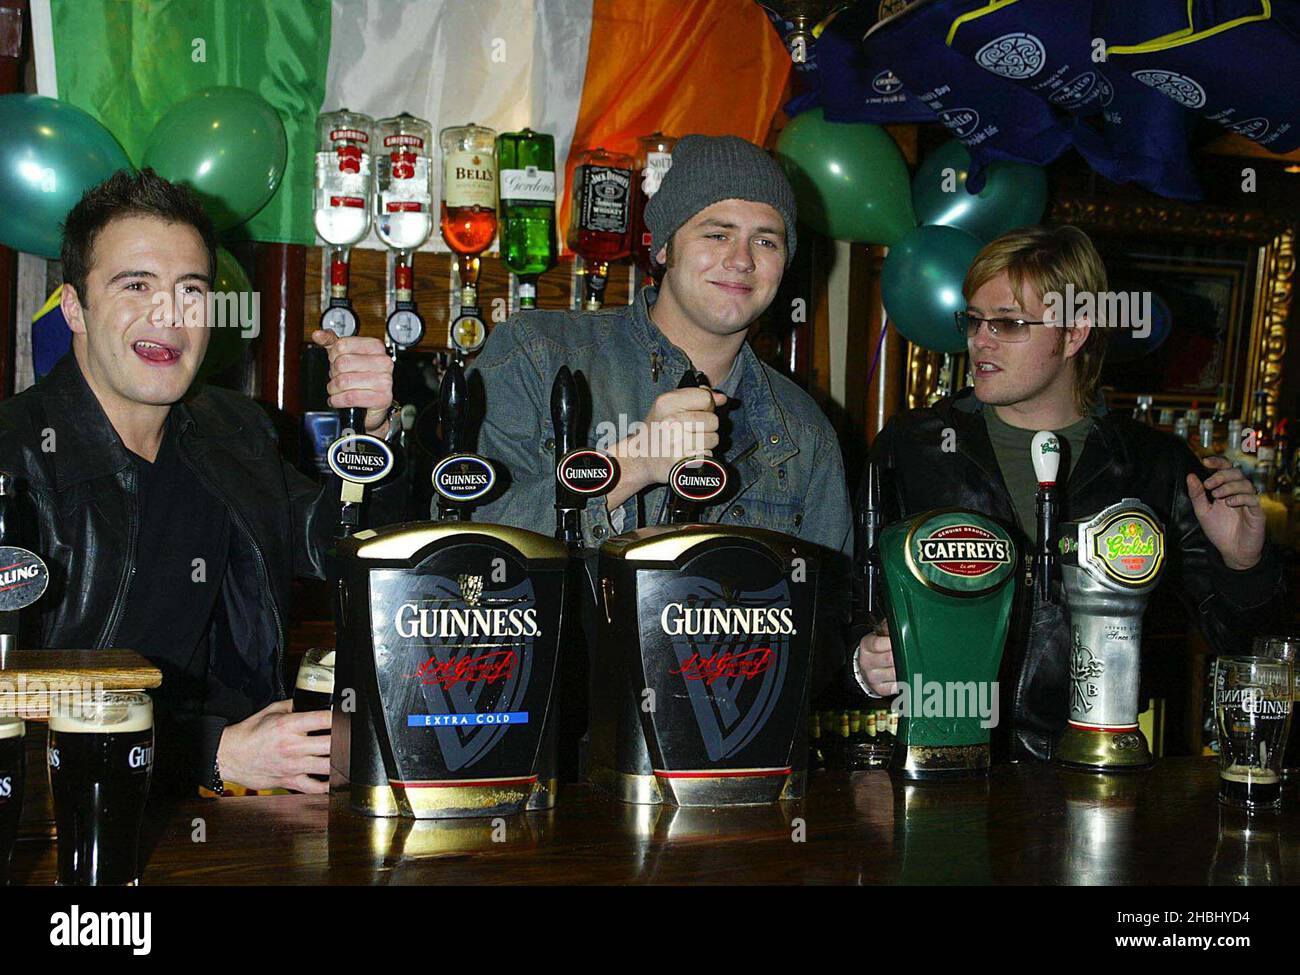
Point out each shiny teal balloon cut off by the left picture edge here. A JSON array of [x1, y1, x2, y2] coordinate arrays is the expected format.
[[0, 95, 131, 257]]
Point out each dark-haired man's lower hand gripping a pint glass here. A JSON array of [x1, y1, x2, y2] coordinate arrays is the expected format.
[[217, 701, 330, 793]]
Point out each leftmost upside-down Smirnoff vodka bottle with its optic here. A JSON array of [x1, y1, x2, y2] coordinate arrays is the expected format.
[[313, 108, 374, 338]]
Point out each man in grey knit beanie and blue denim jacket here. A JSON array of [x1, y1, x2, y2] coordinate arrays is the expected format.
[[475, 135, 853, 696]]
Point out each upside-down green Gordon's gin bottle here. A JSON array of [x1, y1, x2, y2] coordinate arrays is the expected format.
[[497, 129, 558, 308]]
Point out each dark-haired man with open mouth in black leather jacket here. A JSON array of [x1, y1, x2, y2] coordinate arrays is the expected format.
[[0, 169, 403, 792]]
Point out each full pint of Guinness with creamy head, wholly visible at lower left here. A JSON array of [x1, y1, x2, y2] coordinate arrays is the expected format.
[[46, 690, 153, 887]]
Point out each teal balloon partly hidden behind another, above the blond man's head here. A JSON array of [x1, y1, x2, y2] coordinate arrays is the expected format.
[[911, 139, 1048, 243]]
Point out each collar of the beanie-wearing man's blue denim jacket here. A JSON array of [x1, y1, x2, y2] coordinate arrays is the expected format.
[[632, 285, 800, 467]]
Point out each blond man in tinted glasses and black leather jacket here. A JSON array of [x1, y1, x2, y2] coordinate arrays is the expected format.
[[852, 228, 1284, 759]]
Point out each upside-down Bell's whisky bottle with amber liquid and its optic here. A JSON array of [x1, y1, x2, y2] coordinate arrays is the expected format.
[[438, 122, 497, 355]]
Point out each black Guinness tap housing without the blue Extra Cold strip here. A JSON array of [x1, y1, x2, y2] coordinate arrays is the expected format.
[[590, 374, 819, 806]]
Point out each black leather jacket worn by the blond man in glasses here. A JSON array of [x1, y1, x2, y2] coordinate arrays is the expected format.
[[858, 389, 1286, 759]]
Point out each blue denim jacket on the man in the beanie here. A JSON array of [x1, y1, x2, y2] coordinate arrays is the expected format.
[[471, 287, 853, 691]]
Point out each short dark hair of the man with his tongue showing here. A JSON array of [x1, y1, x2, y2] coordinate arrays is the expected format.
[[60, 169, 217, 306]]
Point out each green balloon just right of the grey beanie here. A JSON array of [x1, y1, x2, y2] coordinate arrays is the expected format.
[[776, 108, 917, 247]]
